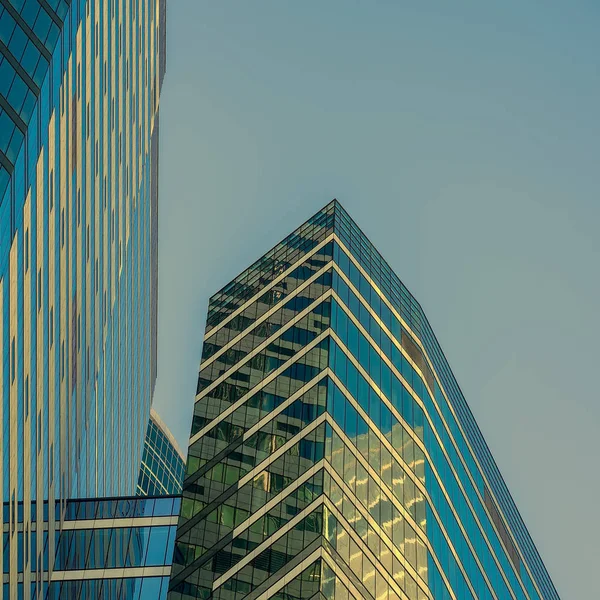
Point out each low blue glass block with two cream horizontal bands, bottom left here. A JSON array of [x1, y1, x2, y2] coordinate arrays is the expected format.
[[3, 496, 181, 600]]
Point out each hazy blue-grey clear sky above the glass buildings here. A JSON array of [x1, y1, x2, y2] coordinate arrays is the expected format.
[[154, 0, 600, 600]]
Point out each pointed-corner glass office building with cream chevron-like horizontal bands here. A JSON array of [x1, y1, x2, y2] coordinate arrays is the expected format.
[[169, 201, 558, 600]]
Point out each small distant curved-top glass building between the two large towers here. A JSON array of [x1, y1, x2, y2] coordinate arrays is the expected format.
[[137, 409, 185, 496]]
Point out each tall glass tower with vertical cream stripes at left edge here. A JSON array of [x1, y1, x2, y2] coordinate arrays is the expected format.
[[0, 0, 165, 598]]
